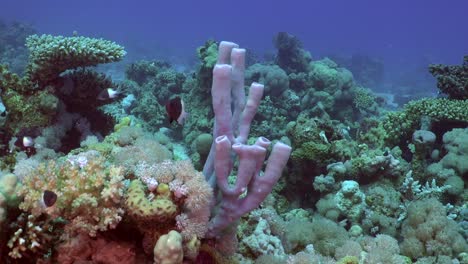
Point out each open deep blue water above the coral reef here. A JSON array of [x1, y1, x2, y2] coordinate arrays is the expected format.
[[0, 0, 468, 91]]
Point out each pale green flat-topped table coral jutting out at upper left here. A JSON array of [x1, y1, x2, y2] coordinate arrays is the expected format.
[[26, 35, 126, 84]]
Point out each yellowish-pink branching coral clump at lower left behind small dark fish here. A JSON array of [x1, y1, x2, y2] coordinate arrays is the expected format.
[[19, 151, 124, 236]]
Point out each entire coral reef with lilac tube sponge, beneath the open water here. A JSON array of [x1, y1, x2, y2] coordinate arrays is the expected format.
[[0, 21, 468, 264]]
